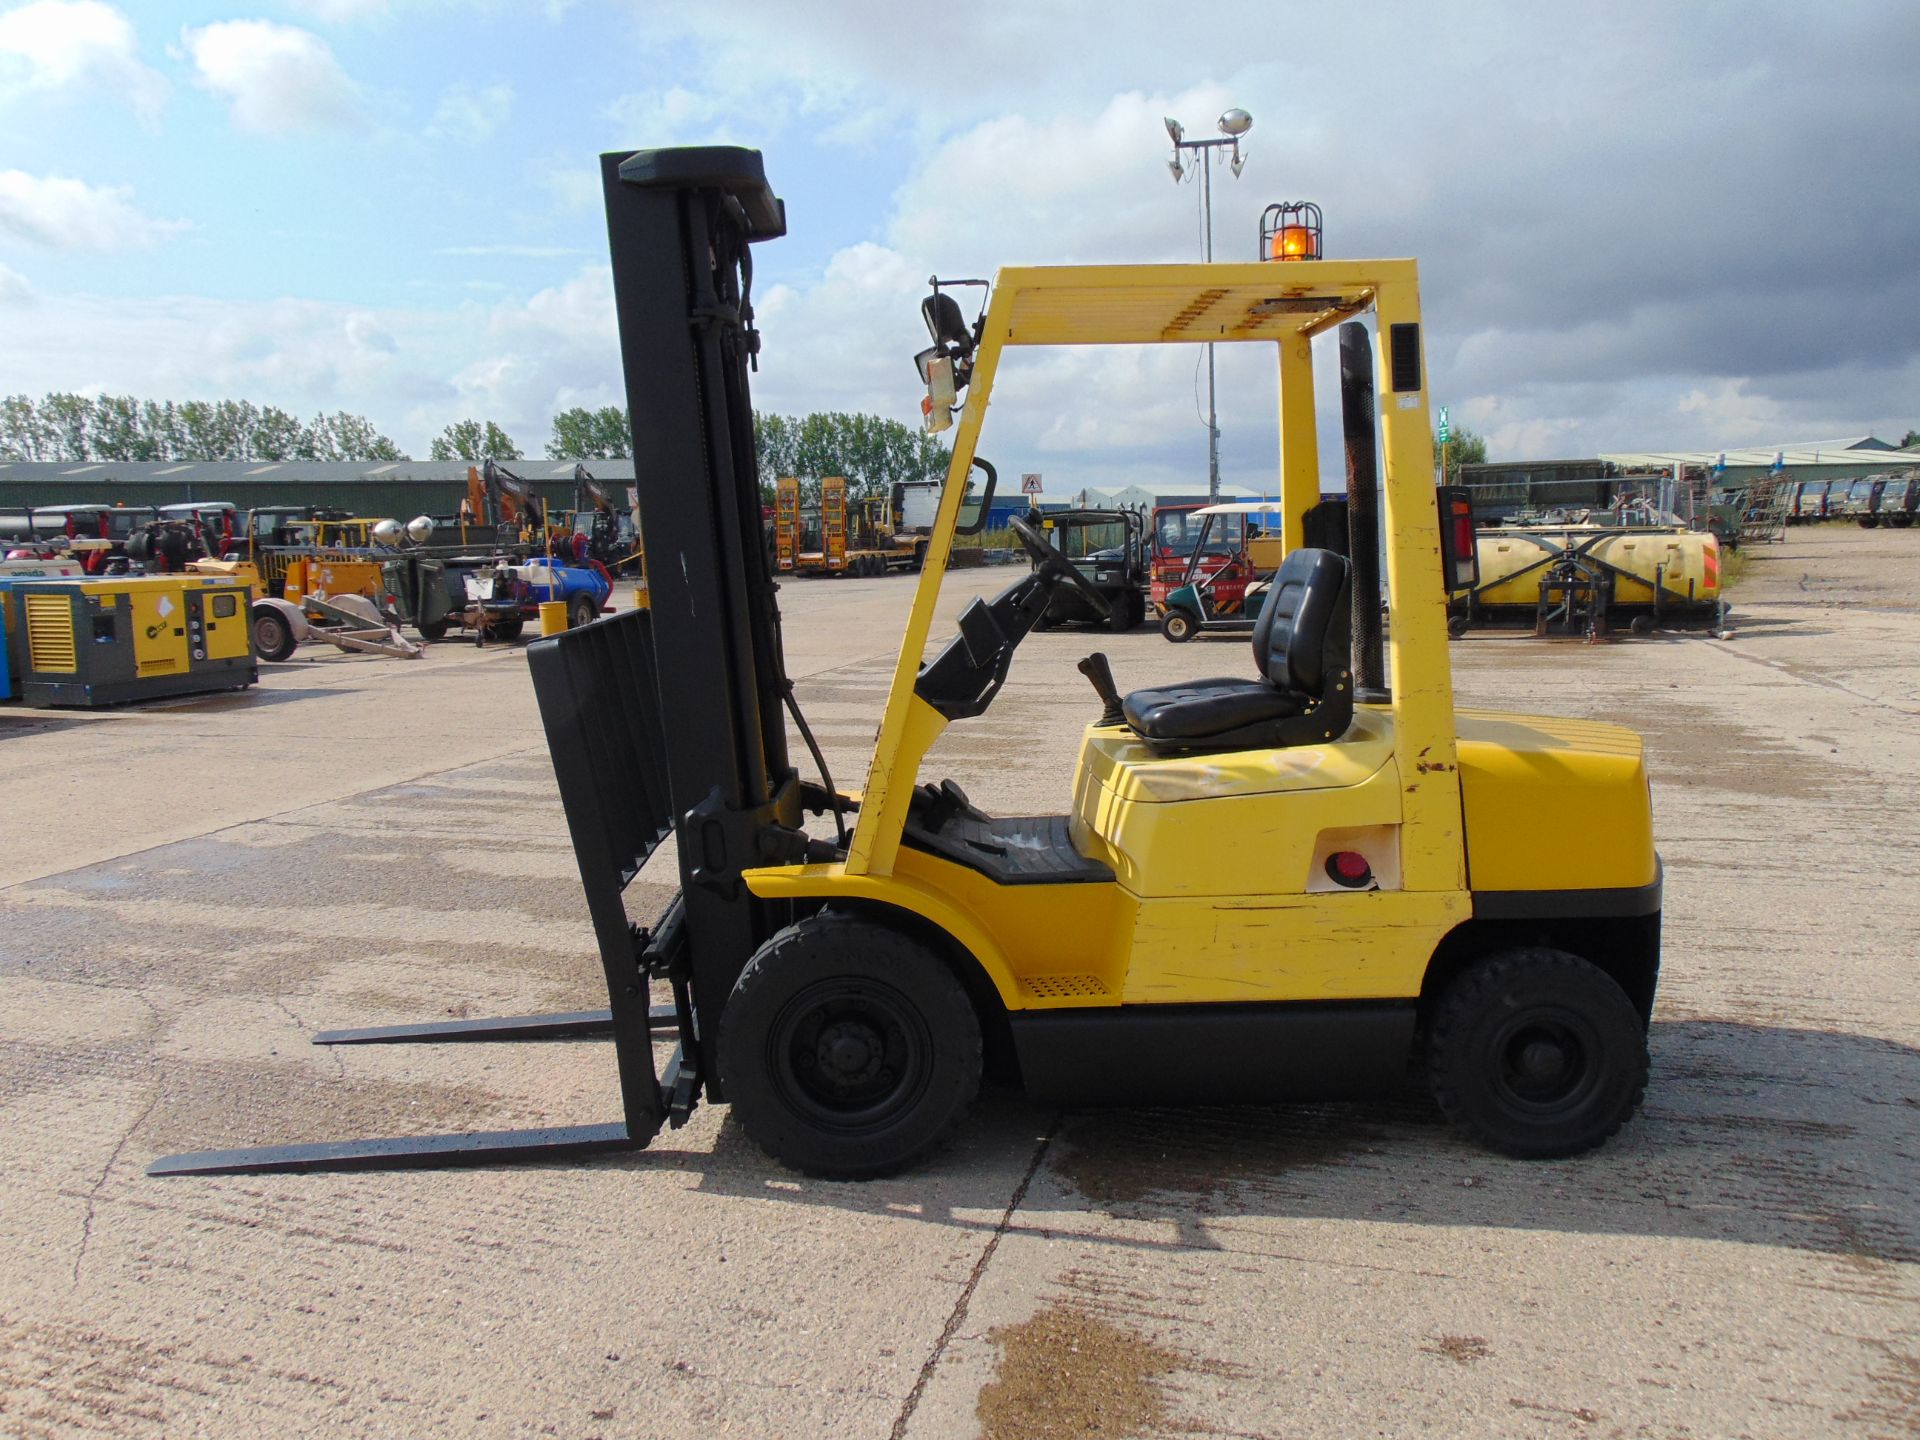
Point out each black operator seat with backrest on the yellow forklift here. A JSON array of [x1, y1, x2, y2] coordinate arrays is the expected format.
[[1121, 549, 1354, 751]]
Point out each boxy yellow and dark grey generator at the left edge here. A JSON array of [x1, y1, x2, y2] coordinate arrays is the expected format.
[[4, 574, 259, 707]]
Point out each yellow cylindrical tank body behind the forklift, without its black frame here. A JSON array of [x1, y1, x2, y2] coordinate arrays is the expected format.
[[1455, 524, 1720, 612]]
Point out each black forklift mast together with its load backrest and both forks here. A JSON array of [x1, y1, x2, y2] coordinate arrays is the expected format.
[[148, 148, 810, 1175]]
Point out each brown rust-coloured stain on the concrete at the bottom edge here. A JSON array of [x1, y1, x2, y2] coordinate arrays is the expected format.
[[973, 1302, 1190, 1440]]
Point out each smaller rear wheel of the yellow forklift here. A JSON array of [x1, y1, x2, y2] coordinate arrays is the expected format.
[[1427, 947, 1647, 1160]]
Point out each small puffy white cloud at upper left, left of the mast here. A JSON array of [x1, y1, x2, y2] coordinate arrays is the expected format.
[[180, 19, 361, 134]]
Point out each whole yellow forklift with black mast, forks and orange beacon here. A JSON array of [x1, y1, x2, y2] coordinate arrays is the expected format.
[[154, 148, 1661, 1179]]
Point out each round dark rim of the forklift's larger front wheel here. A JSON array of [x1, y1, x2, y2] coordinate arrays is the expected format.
[[766, 977, 933, 1135]]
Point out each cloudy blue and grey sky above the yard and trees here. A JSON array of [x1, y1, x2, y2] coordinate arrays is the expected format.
[[0, 0, 1920, 493]]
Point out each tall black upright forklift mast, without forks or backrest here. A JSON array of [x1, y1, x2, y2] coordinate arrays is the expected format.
[[601, 146, 806, 1098]]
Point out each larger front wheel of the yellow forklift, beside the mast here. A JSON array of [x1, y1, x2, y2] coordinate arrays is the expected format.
[[720, 912, 981, 1181]]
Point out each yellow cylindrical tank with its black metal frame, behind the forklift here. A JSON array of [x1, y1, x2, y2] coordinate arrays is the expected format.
[[1450, 520, 1724, 639]]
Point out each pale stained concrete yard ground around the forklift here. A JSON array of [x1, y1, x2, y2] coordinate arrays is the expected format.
[[0, 528, 1920, 1440]]
